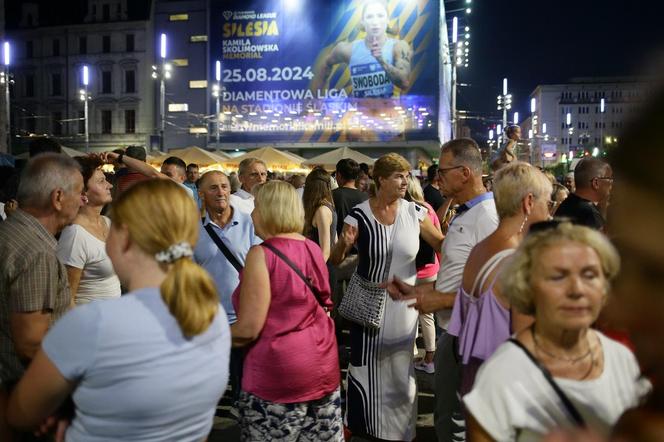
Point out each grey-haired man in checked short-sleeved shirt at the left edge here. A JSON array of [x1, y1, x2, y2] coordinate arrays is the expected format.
[[0, 153, 83, 440]]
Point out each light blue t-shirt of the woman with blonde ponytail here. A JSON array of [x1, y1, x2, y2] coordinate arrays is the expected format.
[[42, 288, 231, 442]]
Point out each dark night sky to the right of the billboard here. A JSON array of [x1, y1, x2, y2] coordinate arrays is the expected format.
[[460, 0, 664, 134]]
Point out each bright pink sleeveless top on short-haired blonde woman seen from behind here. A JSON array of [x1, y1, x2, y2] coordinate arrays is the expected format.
[[233, 237, 340, 403]]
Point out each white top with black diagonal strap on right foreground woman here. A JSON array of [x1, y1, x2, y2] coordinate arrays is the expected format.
[[463, 331, 651, 441]]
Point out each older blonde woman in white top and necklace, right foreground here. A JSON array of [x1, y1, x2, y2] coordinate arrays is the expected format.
[[464, 221, 650, 442]]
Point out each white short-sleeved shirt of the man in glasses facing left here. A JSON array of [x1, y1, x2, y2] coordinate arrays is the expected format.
[[436, 193, 498, 330]]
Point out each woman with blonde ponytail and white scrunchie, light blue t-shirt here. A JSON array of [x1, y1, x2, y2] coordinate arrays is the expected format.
[[8, 180, 230, 441]]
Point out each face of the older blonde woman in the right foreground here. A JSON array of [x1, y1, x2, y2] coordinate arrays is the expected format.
[[531, 241, 607, 330]]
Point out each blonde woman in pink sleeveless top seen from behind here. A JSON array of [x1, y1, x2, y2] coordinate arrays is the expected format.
[[231, 181, 343, 441]]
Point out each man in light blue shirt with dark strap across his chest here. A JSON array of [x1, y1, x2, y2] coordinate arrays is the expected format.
[[194, 170, 261, 410]]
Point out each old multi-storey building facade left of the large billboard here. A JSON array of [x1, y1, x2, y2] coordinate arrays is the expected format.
[[7, 0, 155, 150]]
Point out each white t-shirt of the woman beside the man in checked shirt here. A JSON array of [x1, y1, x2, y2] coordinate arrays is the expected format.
[[57, 217, 121, 305]]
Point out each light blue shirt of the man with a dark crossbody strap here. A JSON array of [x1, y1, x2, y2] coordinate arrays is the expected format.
[[194, 205, 262, 324]]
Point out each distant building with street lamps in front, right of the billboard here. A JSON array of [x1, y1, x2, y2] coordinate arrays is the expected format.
[[521, 77, 649, 164]]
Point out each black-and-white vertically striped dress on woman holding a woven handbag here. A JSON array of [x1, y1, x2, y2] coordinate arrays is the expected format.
[[344, 200, 427, 441]]
